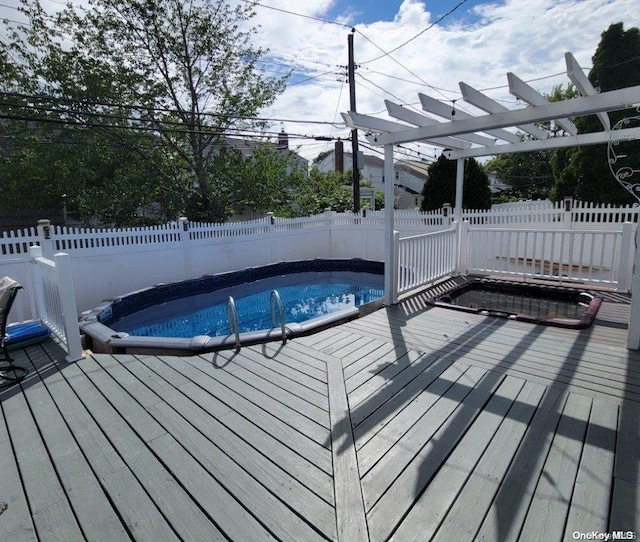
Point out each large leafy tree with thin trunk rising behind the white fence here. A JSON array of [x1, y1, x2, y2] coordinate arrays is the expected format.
[[0, 0, 286, 220]]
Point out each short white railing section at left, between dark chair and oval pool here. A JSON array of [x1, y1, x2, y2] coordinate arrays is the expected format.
[[30, 246, 83, 362]]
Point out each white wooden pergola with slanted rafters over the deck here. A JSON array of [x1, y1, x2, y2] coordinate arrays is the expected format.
[[342, 53, 640, 350]]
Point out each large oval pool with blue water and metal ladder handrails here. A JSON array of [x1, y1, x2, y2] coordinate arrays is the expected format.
[[80, 259, 384, 352]]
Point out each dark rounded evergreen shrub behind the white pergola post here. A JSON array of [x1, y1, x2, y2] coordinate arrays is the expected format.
[[420, 155, 491, 211]]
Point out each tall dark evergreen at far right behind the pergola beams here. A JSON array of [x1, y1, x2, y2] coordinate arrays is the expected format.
[[553, 23, 640, 204]]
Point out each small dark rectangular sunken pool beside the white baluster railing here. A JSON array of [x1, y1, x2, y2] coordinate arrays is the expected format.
[[428, 278, 602, 329]]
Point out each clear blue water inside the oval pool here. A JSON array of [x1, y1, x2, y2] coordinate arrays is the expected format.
[[110, 271, 384, 337]]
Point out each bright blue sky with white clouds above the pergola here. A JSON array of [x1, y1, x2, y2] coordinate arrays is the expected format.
[[0, 0, 640, 165]]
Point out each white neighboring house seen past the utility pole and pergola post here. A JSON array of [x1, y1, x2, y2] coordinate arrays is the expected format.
[[317, 151, 427, 209]]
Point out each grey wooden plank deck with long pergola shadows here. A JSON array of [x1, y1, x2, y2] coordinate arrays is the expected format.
[[0, 286, 640, 542]]
